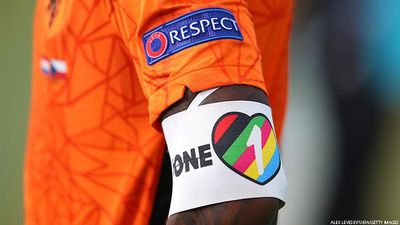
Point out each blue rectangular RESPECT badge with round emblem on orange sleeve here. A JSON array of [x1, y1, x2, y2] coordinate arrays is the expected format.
[[142, 8, 243, 65]]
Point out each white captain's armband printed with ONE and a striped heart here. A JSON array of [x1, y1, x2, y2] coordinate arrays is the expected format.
[[162, 89, 287, 215]]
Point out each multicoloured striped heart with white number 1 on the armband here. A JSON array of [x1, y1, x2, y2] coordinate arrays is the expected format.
[[212, 112, 281, 185]]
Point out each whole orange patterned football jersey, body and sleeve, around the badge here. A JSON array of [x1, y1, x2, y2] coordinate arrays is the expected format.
[[25, 0, 292, 225]]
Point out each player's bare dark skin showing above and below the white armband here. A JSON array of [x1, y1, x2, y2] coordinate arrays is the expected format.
[[161, 85, 280, 225]]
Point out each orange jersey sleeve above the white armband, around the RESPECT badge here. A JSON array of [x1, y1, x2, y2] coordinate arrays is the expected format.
[[108, 0, 280, 126]]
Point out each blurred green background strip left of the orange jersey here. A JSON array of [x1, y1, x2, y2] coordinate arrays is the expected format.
[[0, 0, 34, 225]]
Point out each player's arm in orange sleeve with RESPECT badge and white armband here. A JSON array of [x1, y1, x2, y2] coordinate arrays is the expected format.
[[106, 0, 286, 224]]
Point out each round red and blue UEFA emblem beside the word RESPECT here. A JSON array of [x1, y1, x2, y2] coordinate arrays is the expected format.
[[146, 31, 168, 59]]
